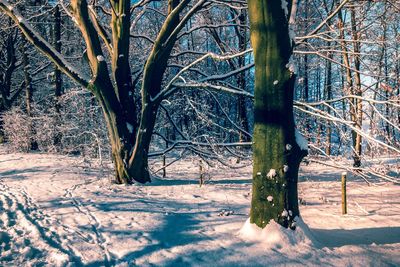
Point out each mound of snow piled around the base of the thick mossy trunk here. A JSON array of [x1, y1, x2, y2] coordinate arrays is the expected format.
[[239, 217, 316, 248]]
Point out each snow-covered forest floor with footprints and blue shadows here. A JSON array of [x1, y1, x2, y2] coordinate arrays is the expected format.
[[0, 147, 400, 266]]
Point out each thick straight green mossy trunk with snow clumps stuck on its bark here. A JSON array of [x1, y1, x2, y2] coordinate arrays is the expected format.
[[248, 0, 307, 228]]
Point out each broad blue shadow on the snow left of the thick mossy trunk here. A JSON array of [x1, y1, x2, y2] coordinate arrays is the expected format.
[[40, 195, 250, 266]]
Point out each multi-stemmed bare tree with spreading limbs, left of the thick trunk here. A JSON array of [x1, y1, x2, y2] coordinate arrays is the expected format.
[[0, 0, 211, 183]]
